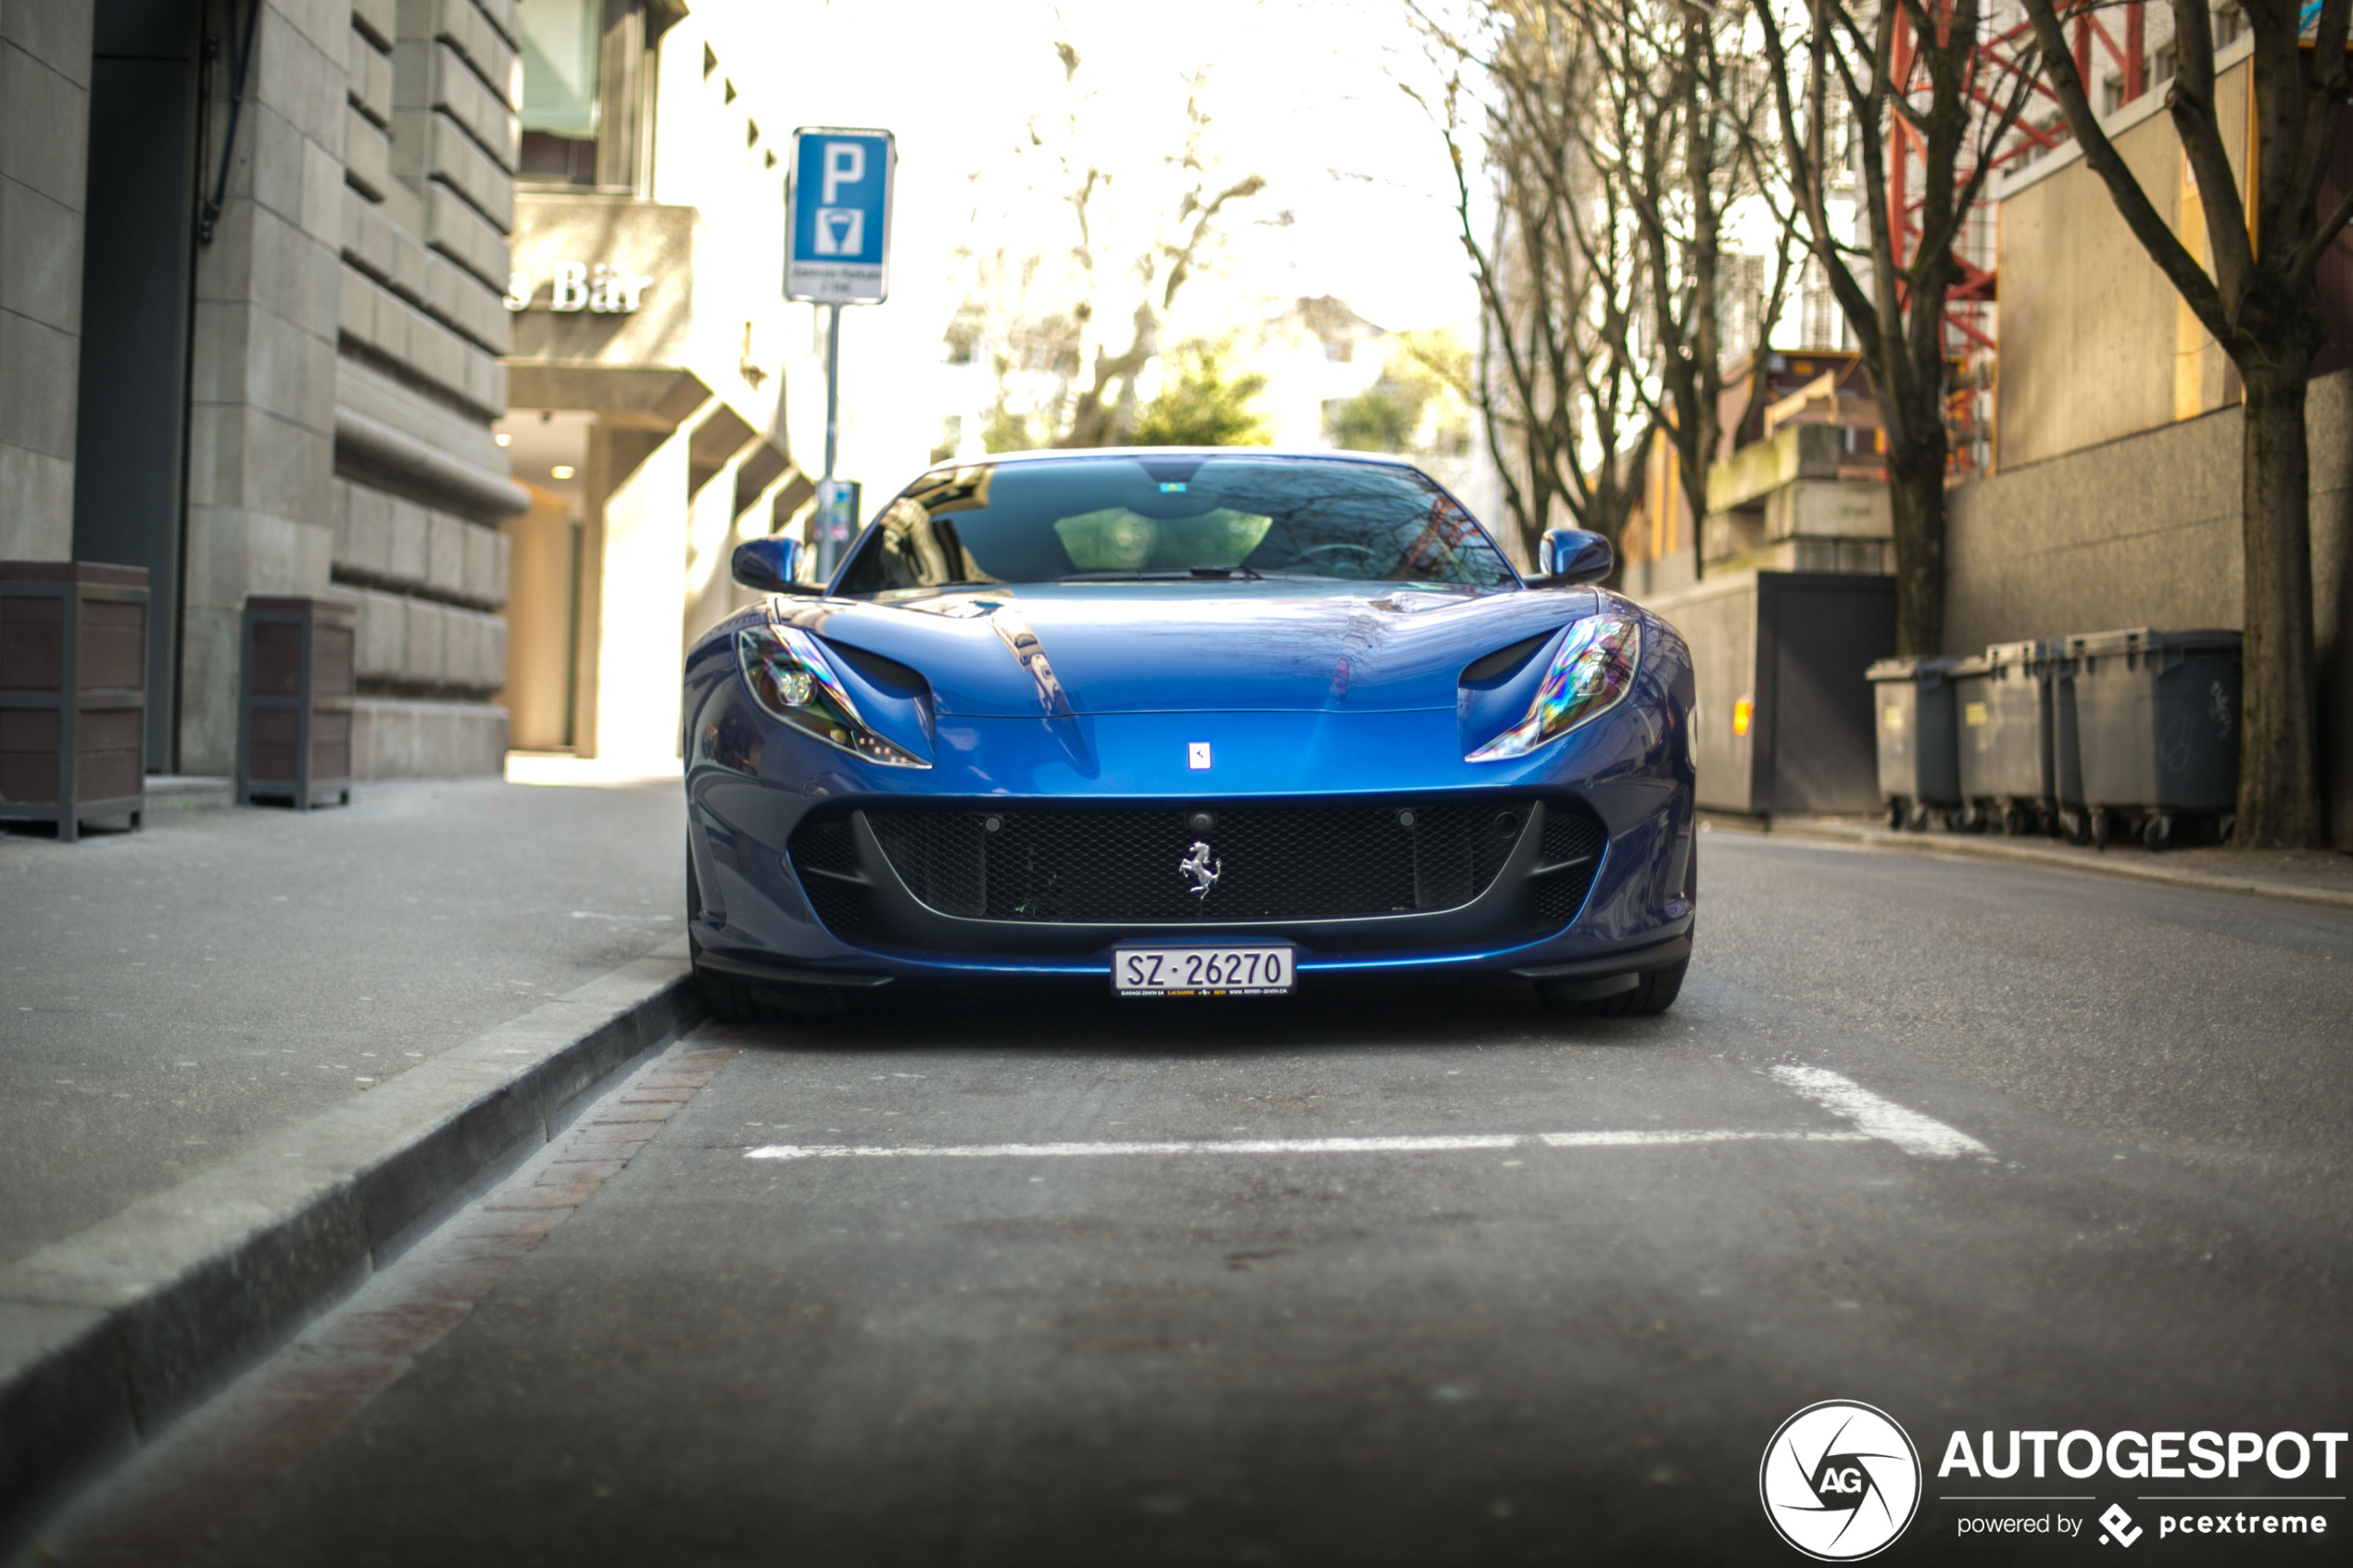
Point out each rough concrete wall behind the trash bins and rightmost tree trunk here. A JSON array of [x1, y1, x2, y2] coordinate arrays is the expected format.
[[1944, 371, 2353, 848]]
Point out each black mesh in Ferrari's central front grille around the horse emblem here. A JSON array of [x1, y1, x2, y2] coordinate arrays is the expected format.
[[856, 802, 1527, 924]]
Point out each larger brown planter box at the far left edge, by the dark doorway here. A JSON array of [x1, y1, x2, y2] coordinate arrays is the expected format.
[[0, 562, 148, 844]]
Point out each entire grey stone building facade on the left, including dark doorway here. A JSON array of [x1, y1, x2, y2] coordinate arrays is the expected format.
[[0, 0, 530, 778]]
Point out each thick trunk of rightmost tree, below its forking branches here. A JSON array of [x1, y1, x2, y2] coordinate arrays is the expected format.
[[2235, 369, 2320, 848]]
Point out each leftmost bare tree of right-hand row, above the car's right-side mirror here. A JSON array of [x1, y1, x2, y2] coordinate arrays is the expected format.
[[1404, 0, 1650, 562]]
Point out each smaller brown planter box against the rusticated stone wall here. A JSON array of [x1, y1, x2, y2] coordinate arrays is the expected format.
[[238, 597, 360, 811]]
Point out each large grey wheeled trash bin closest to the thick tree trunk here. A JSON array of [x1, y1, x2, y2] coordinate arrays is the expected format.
[[2066, 628, 2240, 848]]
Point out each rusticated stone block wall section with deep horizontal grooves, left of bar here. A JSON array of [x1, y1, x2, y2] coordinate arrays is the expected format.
[[330, 0, 527, 778]]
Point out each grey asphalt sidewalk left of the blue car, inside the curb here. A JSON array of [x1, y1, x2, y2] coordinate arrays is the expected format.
[[0, 778, 685, 1267]]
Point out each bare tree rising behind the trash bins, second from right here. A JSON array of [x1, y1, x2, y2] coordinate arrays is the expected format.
[[1751, 0, 2033, 654]]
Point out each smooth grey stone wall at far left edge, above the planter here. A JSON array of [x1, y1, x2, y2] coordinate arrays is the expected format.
[[0, 0, 92, 562]]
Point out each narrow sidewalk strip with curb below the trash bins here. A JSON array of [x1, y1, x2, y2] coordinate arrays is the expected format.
[[1731, 813, 2353, 909]]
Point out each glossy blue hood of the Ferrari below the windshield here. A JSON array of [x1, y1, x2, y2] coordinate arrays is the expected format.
[[772, 583, 1600, 717]]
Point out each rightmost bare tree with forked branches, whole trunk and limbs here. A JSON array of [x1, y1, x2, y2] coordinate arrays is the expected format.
[[2026, 0, 2353, 847]]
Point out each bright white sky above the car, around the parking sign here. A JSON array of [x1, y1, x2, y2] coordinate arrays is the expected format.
[[713, 0, 1478, 489]]
